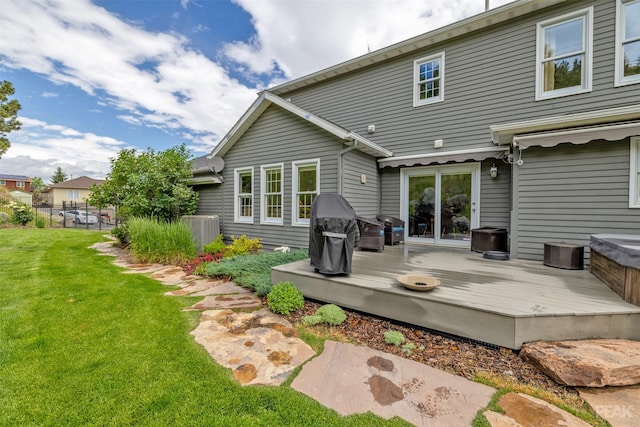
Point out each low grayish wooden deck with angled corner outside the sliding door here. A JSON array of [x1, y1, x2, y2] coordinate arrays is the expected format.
[[271, 244, 640, 349]]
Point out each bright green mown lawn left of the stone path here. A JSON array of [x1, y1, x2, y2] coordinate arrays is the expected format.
[[0, 228, 406, 426]]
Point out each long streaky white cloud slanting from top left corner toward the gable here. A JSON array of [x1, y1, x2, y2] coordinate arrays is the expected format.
[[0, 0, 258, 152]]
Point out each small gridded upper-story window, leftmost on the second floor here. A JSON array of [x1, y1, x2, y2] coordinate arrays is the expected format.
[[413, 52, 444, 107]]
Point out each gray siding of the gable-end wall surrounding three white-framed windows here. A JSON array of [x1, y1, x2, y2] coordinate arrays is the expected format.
[[215, 105, 344, 248]]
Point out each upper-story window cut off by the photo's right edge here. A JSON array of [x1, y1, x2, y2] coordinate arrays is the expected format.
[[616, 0, 640, 86]]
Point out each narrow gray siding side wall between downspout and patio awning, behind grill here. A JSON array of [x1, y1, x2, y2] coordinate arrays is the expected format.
[[342, 151, 380, 218]]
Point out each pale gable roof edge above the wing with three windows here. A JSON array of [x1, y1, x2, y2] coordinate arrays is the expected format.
[[208, 92, 393, 157]]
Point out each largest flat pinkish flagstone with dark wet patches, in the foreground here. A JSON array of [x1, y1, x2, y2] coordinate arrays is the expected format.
[[291, 341, 495, 427]]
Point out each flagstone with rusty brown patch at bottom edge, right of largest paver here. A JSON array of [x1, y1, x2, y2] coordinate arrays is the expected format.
[[492, 393, 589, 427]]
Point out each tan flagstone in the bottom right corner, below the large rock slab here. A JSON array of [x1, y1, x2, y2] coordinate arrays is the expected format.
[[578, 386, 640, 427]]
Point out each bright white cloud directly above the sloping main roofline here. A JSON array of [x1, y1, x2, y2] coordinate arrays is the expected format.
[[224, 0, 513, 78]]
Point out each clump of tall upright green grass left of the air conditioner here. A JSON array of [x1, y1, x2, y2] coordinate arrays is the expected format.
[[127, 218, 197, 265]]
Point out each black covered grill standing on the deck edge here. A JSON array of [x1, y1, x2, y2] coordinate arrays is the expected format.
[[309, 193, 358, 274]]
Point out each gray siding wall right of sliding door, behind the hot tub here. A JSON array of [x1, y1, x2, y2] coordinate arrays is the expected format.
[[514, 139, 640, 260]]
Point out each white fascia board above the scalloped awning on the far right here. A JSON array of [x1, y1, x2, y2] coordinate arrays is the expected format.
[[489, 104, 640, 145]]
